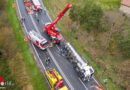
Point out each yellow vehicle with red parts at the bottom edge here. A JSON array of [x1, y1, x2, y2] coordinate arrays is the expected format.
[[45, 68, 68, 90]]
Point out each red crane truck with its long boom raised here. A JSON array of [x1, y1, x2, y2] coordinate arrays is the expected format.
[[44, 4, 72, 44]]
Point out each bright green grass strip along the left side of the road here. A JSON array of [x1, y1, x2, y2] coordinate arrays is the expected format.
[[6, 0, 48, 90]]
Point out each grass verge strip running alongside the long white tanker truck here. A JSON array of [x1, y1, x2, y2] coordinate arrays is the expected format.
[[72, 40, 123, 90]]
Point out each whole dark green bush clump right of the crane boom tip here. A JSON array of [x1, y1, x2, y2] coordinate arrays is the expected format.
[[69, 1, 103, 31]]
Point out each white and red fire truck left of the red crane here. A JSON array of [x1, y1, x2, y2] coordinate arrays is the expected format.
[[28, 31, 49, 50]]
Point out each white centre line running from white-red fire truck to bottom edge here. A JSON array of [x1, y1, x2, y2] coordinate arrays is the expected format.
[[47, 48, 74, 90]]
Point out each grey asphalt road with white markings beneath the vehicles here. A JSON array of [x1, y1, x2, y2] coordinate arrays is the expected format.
[[16, 0, 98, 90]]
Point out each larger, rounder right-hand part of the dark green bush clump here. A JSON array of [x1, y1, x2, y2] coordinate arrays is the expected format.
[[80, 3, 103, 30]]
